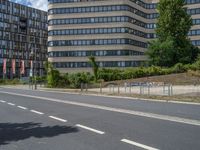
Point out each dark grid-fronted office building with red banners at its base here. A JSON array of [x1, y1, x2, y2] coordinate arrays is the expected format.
[[0, 0, 48, 79]]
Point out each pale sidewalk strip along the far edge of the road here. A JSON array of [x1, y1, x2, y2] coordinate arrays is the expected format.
[[0, 85, 200, 105]]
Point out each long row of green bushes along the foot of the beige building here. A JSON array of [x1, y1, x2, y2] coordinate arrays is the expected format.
[[45, 58, 200, 88]]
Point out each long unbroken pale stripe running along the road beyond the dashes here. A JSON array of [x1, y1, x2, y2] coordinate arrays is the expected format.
[[0, 91, 200, 126]]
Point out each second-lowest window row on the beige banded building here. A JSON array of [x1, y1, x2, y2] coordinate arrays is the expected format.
[[48, 50, 144, 57]]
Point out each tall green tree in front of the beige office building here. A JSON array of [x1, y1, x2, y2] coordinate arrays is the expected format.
[[147, 0, 200, 66]]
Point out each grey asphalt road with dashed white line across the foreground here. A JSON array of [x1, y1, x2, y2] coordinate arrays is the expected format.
[[0, 88, 200, 150]]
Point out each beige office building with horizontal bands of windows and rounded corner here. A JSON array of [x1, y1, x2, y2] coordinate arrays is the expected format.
[[48, 0, 200, 73]]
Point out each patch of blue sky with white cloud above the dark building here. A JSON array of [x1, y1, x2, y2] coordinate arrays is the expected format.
[[11, 0, 48, 11]]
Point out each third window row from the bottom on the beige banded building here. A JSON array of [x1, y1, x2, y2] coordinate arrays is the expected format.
[[48, 39, 147, 48]]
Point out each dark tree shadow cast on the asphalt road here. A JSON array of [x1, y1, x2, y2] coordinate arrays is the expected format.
[[0, 122, 78, 145]]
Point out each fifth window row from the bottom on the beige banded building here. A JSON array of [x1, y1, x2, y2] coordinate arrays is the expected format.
[[49, 16, 146, 28]]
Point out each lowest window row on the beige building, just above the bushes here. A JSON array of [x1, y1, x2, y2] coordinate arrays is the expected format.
[[53, 61, 143, 68]]
